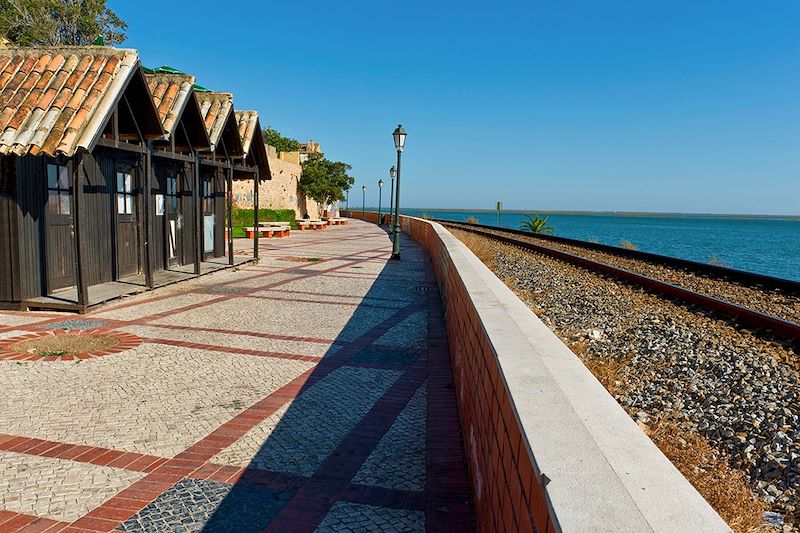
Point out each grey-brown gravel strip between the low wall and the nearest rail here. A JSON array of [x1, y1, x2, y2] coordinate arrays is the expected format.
[[451, 230, 800, 530]]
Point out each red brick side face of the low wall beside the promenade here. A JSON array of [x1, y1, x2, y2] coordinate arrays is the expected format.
[[349, 211, 555, 533]]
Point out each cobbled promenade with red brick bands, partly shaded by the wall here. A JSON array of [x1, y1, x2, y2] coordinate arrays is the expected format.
[[0, 221, 472, 532]]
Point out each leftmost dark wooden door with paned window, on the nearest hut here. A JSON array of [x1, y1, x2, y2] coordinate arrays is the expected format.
[[44, 163, 75, 293]]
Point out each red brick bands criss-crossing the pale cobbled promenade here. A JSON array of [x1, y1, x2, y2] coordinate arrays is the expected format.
[[0, 221, 473, 532]]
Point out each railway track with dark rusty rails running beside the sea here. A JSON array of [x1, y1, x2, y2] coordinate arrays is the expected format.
[[436, 220, 800, 346]]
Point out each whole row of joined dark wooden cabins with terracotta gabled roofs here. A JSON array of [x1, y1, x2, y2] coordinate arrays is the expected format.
[[0, 46, 269, 312]]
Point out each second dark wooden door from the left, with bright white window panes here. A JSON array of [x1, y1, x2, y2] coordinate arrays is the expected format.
[[114, 168, 139, 278]]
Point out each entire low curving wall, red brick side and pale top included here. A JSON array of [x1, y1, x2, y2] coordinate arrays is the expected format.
[[347, 211, 730, 533]]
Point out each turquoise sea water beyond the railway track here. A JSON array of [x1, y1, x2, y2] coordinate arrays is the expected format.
[[402, 209, 800, 281]]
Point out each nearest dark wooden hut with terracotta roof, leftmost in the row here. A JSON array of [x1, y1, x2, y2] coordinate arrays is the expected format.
[[0, 46, 164, 310]]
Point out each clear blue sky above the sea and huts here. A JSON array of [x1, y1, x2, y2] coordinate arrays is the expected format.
[[115, 0, 800, 214]]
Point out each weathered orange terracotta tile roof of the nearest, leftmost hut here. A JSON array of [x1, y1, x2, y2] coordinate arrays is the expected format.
[[0, 46, 163, 156]]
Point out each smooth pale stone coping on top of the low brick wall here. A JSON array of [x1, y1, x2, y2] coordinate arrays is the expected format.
[[419, 219, 730, 533]]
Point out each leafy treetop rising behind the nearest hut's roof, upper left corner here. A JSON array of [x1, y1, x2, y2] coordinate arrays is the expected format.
[[0, 0, 128, 46]]
